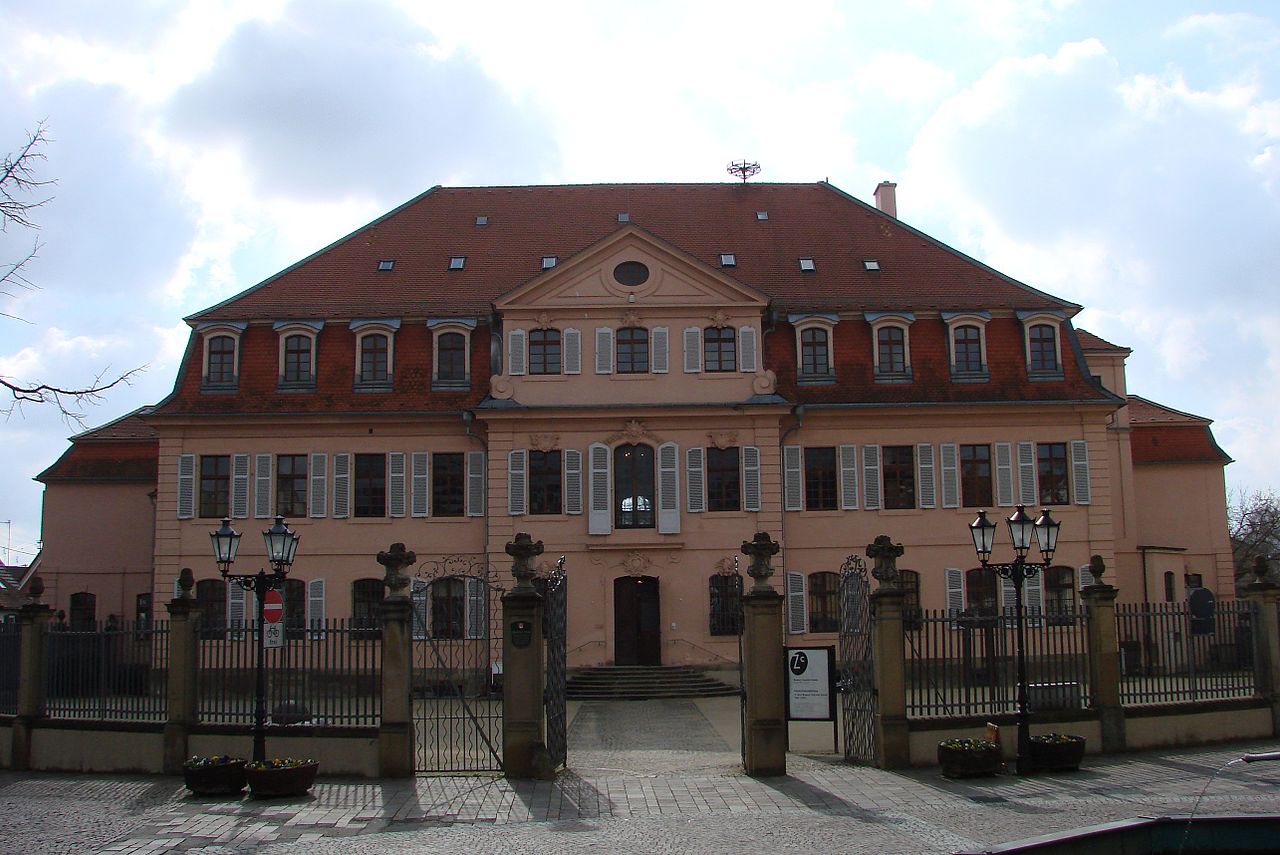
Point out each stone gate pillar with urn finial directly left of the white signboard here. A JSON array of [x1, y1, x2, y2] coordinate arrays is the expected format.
[[742, 531, 787, 777]]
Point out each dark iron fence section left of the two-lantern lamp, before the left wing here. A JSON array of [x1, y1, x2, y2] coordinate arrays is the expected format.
[[44, 621, 169, 722]]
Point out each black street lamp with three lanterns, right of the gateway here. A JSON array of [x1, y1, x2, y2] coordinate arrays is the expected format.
[[969, 504, 1061, 774]]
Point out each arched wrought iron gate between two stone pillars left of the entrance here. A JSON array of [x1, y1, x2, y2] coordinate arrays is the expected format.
[[411, 555, 503, 772]]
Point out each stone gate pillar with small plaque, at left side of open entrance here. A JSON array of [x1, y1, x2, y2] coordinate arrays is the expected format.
[[502, 531, 554, 778]]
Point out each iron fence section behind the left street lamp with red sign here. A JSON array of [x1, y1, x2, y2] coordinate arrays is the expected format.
[[196, 618, 383, 727]]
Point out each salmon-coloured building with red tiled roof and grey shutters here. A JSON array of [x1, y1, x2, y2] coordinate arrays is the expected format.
[[30, 183, 1234, 667]]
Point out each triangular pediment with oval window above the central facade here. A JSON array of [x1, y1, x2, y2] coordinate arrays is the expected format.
[[494, 225, 768, 312]]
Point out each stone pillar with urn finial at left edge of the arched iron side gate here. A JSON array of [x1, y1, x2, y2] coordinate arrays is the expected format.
[[378, 543, 417, 778]]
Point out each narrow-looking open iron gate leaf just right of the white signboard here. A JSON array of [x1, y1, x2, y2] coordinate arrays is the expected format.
[[840, 555, 877, 765]]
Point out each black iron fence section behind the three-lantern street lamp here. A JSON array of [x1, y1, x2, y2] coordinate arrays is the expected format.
[[904, 609, 1089, 718]]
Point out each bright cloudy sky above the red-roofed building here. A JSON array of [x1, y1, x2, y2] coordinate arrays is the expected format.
[[0, 0, 1280, 563]]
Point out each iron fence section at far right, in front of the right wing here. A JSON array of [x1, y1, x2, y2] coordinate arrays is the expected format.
[[1116, 600, 1257, 707]]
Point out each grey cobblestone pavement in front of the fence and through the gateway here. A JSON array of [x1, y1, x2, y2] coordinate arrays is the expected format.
[[0, 701, 1280, 855]]
